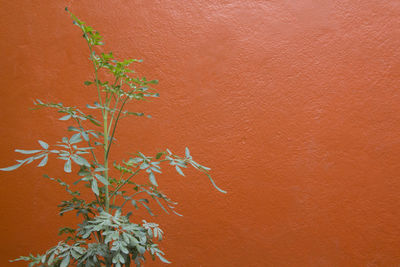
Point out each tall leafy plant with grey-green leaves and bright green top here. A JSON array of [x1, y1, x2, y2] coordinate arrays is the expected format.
[[0, 9, 225, 267]]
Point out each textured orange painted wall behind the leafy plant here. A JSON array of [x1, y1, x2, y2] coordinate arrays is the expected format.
[[0, 0, 400, 266]]
